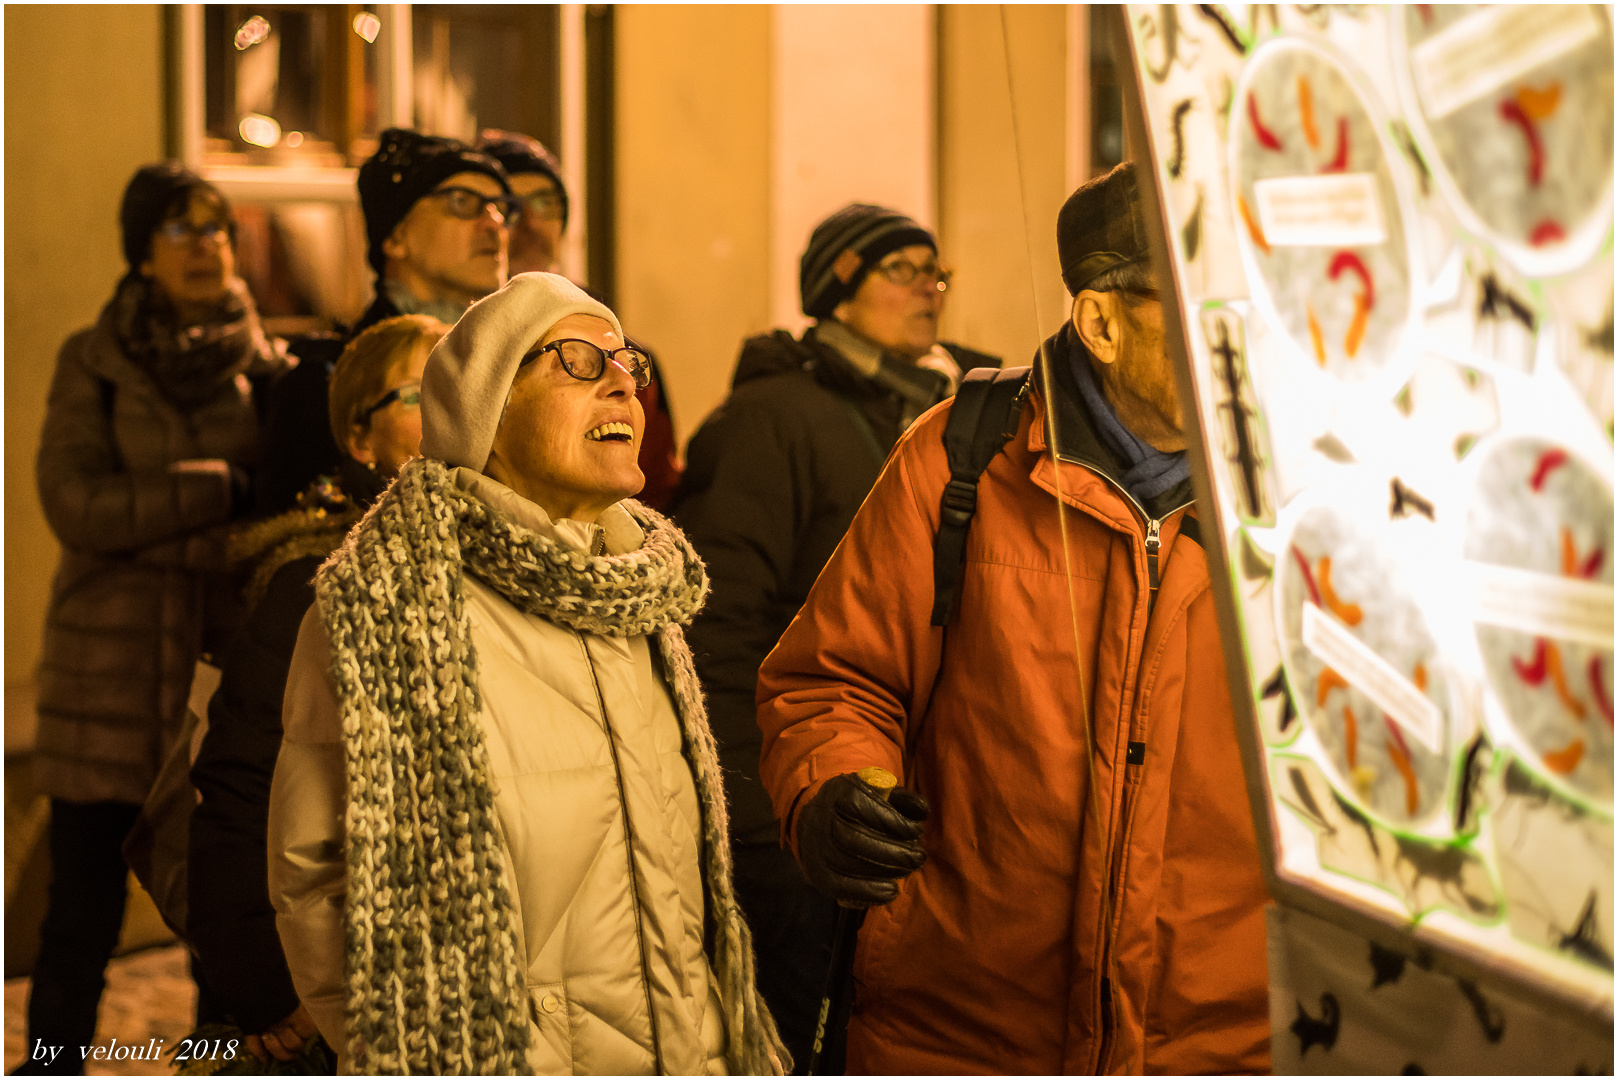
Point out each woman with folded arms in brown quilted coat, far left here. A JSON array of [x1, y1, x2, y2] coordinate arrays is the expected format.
[[28, 164, 286, 1072]]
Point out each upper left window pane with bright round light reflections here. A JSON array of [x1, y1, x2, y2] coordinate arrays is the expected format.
[[204, 3, 379, 165]]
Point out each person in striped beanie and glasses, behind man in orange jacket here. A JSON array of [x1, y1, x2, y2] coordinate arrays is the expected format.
[[675, 204, 1000, 1072]]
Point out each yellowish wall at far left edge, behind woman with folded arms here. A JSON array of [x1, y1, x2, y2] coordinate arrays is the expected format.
[[5, 3, 163, 748]]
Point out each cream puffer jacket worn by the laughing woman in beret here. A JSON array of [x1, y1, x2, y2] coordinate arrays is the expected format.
[[269, 470, 725, 1075]]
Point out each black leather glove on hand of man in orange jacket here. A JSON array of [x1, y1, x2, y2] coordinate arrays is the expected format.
[[798, 772, 929, 907]]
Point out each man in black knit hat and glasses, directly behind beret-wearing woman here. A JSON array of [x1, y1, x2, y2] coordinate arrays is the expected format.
[[256, 128, 518, 517]]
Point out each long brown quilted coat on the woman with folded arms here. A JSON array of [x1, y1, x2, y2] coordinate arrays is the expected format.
[[34, 293, 285, 803]]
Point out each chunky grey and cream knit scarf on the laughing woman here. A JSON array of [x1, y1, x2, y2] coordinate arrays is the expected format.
[[316, 458, 791, 1074]]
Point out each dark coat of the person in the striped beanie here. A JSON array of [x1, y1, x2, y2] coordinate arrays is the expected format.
[[673, 329, 1000, 847]]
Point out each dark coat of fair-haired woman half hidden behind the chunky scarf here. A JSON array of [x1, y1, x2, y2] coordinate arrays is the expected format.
[[186, 458, 382, 1031]]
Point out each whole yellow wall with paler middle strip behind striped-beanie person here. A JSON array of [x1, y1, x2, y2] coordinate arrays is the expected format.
[[616, 5, 1069, 444]]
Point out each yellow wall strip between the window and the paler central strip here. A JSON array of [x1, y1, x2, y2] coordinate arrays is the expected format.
[[615, 5, 770, 445]]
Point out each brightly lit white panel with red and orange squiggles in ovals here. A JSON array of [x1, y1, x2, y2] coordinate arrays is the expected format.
[[1126, 5, 1615, 1029]]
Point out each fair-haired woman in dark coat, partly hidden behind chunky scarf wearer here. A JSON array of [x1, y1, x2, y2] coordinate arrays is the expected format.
[[186, 316, 450, 1064]]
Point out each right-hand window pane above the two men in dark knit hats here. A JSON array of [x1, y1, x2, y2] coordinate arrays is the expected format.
[[411, 3, 560, 149]]
